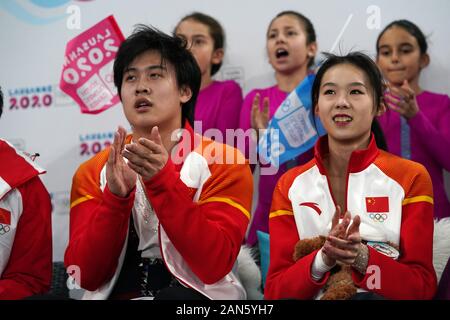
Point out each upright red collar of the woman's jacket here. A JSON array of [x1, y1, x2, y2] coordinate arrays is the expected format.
[[314, 133, 380, 175]]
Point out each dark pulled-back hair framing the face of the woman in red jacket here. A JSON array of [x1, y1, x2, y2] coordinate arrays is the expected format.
[[311, 52, 386, 111]]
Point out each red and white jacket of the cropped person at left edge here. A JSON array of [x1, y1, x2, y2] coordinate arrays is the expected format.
[[0, 139, 52, 300]]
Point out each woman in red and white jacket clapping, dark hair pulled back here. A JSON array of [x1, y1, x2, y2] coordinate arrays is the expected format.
[[264, 53, 437, 299]]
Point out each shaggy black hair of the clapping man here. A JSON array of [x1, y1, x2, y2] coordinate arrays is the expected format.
[[114, 24, 201, 125]]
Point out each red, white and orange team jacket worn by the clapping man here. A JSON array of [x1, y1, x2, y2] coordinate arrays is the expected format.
[[65, 126, 253, 299]]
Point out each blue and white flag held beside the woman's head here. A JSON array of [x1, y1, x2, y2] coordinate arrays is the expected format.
[[258, 74, 325, 167]]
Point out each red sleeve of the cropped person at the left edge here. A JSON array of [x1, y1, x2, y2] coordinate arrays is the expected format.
[[0, 177, 52, 300]]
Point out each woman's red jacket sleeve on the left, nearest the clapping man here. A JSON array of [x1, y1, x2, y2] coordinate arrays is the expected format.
[[264, 169, 330, 299]]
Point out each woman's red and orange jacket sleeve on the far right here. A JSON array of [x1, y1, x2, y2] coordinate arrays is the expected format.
[[353, 161, 437, 299]]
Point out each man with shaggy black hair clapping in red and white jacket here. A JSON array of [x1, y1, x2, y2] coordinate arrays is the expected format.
[[65, 25, 253, 299]]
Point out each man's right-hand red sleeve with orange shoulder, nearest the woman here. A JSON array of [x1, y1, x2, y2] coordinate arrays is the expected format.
[[145, 154, 253, 284]]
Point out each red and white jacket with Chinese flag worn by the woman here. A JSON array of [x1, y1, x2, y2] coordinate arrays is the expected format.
[[265, 136, 436, 299]]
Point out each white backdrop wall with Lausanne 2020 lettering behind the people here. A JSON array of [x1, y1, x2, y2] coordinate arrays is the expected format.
[[0, 0, 450, 260]]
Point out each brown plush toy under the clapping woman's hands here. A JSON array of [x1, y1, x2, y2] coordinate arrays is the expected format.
[[293, 236, 356, 300]]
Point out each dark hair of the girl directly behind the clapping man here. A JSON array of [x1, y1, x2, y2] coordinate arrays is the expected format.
[[173, 12, 225, 76]]
